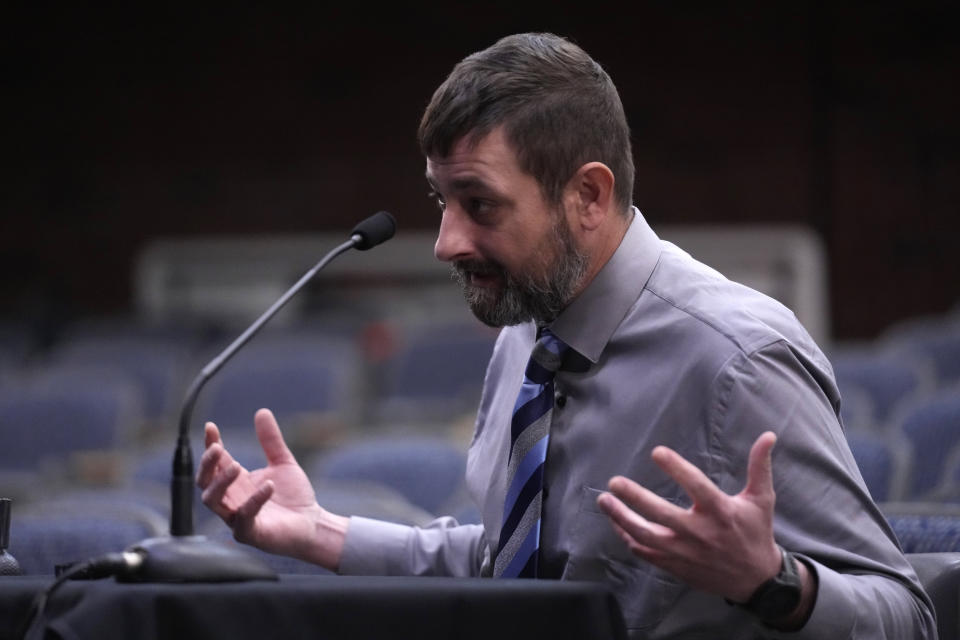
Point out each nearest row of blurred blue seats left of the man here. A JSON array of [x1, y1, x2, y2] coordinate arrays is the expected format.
[[3, 434, 479, 574]]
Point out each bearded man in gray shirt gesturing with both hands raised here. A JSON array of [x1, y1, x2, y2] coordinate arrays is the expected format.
[[197, 34, 936, 640]]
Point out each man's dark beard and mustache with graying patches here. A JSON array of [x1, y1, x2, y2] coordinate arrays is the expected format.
[[451, 210, 589, 327]]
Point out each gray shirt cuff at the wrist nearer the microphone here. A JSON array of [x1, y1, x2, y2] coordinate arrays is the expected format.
[[337, 516, 412, 576]]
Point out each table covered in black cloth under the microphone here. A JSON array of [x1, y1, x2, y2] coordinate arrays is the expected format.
[[0, 575, 626, 640]]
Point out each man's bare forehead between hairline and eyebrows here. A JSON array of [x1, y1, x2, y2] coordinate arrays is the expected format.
[[426, 127, 525, 184]]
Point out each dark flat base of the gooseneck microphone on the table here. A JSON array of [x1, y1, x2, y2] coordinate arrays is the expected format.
[[117, 536, 278, 582]]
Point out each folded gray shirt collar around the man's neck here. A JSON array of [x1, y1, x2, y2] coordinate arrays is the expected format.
[[550, 207, 661, 363]]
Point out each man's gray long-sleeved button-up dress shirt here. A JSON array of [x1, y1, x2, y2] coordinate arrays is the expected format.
[[340, 210, 936, 640]]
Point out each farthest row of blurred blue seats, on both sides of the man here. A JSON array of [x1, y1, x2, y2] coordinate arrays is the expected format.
[[0, 302, 960, 444]]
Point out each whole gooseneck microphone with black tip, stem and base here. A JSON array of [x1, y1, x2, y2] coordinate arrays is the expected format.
[[118, 211, 396, 582]]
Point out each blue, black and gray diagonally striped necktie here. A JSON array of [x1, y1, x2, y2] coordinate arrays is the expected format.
[[493, 329, 569, 578]]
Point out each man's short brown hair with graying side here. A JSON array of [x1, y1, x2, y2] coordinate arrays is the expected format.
[[418, 33, 634, 213]]
